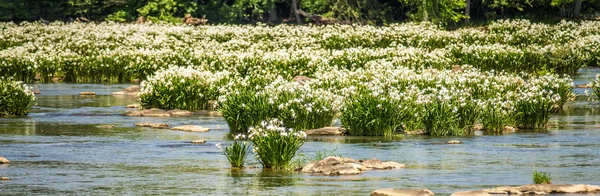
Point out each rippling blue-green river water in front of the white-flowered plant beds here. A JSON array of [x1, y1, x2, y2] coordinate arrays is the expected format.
[[0, 69, 600, 195]]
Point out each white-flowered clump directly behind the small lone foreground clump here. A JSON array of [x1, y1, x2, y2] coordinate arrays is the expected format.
[[219, 78, 339, 131]]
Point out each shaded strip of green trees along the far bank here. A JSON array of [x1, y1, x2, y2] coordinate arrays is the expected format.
[[0, 0, 600, 24]]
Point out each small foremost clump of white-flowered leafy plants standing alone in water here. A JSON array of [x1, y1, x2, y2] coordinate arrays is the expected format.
[[248, 119, 306, 169]]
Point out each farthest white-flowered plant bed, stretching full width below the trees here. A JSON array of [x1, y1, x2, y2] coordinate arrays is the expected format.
[[0, 20, 600, 82]]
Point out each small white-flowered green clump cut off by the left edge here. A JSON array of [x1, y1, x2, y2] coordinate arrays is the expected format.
[[0, 77, 35, 116]]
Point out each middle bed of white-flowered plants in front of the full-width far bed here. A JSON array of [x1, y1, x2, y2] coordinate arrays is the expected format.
[[140, 65, 574, 136]]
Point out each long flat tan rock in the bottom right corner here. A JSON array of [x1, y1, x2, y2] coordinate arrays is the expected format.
[[483, 184, 600, 194]]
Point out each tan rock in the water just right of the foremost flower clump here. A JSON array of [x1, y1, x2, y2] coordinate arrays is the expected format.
[[301, 156, 404, 176]]
